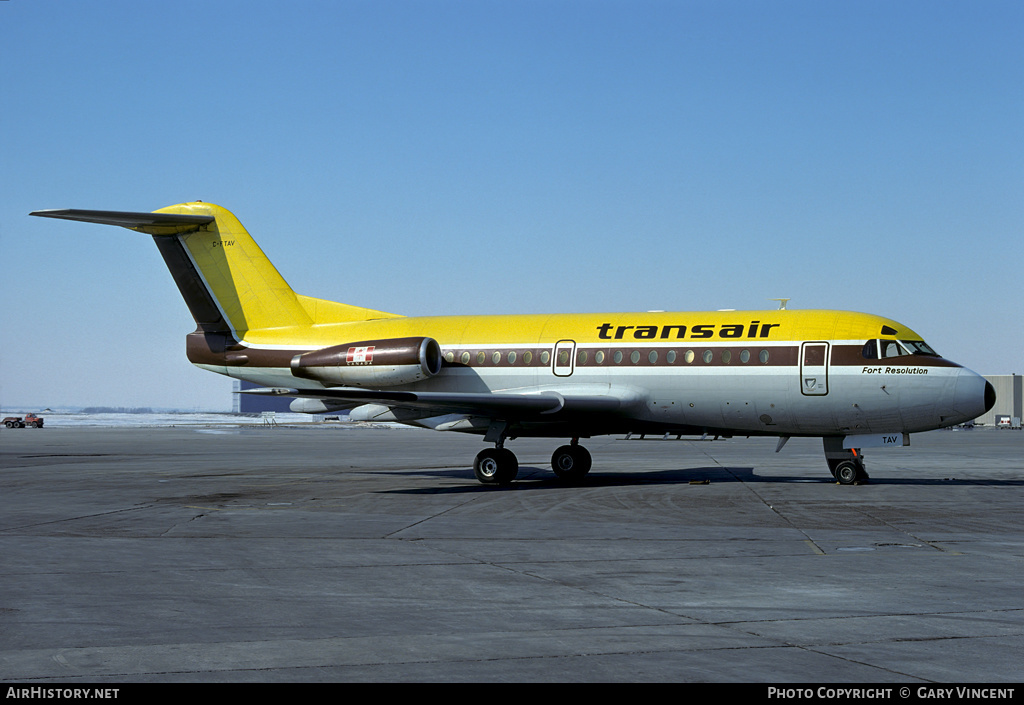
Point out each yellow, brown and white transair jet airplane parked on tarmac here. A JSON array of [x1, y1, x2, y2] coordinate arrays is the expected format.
[[31, 201, 995, 486]]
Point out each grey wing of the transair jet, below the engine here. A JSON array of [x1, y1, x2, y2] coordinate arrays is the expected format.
[[241, 387, 638, 417]]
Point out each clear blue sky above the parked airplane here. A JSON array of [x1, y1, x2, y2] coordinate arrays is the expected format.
[[0, 0, 1024, 410]]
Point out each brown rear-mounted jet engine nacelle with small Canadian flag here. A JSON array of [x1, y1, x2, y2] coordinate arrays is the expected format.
[[292, 338, 441, 387]]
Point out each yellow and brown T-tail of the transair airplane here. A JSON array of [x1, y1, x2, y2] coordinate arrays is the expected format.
[[31, 202, 395, 340]]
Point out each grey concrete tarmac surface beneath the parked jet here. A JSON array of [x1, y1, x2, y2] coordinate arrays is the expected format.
[[0, 425, 1024, 685]]
